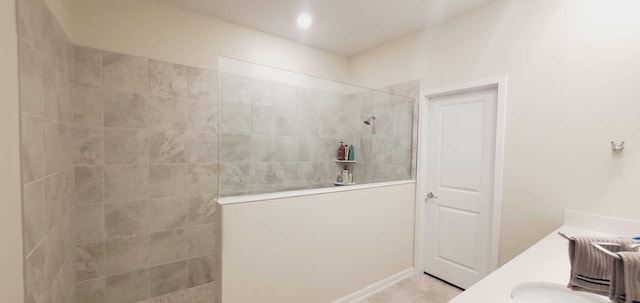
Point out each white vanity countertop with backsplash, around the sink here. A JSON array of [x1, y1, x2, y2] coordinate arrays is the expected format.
[[449, 225, 611, 303]]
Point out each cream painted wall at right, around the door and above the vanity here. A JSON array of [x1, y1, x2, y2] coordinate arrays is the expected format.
[[350, 0, 640, 263]]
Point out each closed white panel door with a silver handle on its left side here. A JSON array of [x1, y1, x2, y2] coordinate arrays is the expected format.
[[421, 88, 497, 289]]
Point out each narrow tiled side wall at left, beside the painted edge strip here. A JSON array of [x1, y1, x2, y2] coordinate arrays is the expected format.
[[18, 0, 75, 303]]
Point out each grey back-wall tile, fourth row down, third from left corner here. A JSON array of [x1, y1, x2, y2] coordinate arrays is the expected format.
[[149, 164, 189, 198]]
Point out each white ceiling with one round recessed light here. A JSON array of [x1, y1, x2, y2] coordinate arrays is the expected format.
[[159, 0, 491, 56]]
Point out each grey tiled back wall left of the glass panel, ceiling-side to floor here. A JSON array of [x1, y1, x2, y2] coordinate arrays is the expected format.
[[71, 47, 218, 303]]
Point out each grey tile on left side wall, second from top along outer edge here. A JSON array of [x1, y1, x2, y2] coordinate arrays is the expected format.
[[19, 39, 43, 115]]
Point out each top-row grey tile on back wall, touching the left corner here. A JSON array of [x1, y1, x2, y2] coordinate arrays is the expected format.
[[73, 46, 102, 87]]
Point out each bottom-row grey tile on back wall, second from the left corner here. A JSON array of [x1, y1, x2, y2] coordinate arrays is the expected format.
[[104, 269, 150, 303]]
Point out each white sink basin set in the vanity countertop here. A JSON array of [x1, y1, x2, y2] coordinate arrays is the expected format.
[[511, 282, 611, 303]]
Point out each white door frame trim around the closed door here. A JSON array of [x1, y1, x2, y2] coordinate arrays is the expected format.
[[413, 75, 508, 273]]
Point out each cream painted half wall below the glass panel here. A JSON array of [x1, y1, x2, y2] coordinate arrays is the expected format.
[[222, 184, 415, 303]]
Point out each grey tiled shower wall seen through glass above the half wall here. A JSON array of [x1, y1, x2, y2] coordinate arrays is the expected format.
[[218, 74, 415, 195]]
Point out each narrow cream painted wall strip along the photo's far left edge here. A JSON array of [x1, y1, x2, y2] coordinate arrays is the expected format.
[[0, 0, 24, 302]]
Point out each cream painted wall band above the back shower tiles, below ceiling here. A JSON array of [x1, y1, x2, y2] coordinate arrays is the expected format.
[[70, 0, 348, 81]]
